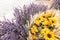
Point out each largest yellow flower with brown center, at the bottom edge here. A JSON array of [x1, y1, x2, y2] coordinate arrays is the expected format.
[[41, 28, 56, 40]]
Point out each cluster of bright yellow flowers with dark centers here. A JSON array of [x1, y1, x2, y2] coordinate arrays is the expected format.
[[30, 9, 58, 40]]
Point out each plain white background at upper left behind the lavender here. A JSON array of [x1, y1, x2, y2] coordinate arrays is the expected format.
[[0, 0, 34, 21]]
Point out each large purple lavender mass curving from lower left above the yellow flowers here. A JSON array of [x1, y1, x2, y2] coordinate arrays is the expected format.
[[0, 4, 47, 40]]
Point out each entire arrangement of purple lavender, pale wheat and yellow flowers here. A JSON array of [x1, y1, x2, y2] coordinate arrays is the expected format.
[[0, 0, 60, 40]]
